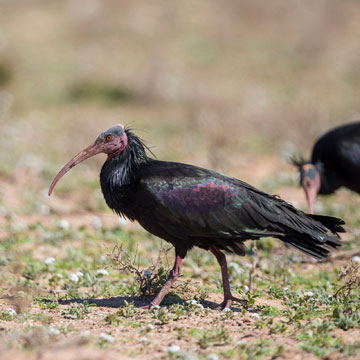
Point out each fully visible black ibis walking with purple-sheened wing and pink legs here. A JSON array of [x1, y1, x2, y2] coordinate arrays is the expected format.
[[49, 125, 344, 308]]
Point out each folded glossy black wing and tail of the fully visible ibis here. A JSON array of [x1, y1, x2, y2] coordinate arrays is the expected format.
[[137, 161, 344, 258]]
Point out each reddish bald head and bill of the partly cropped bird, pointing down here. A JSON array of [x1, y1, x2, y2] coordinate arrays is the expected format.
[[291, 158, 321, 214]]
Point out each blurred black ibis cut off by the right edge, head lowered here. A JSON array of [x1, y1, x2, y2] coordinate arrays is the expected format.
[[292, 122, 360, 214]]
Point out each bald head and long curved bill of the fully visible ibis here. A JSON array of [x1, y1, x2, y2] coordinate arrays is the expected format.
[[49, 124, 128, 196]]
